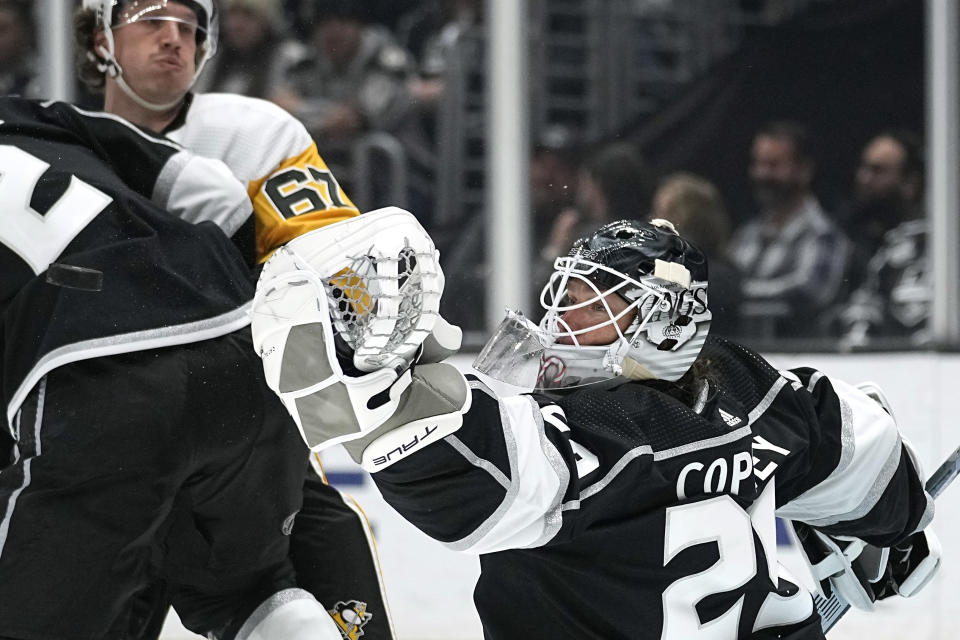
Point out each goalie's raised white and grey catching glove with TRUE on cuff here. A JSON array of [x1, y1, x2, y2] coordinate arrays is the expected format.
[[252, 207, 469, 470]]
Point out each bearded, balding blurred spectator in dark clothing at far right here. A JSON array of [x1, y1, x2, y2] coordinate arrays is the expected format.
[[837, 130, 924, 290]]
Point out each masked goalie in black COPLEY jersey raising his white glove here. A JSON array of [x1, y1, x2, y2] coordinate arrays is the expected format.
[[253, 220, 938, 640]]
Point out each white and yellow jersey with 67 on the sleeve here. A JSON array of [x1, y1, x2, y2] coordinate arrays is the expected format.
[[164, 93, 360, 266]]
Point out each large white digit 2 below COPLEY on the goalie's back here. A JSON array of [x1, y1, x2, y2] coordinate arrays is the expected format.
[[660, 496, 757, 640]]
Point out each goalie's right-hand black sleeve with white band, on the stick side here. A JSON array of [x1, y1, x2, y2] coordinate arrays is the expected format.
[[777, 369, 933, 546]]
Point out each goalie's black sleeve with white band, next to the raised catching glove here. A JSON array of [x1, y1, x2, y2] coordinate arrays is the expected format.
[[373, 380, 577, 553]]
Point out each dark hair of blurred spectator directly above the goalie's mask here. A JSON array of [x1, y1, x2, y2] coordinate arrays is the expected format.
[[583, 142, 653, 220]]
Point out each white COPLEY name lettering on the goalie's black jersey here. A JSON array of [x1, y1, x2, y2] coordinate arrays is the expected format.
[[677, 435, 790, 500]]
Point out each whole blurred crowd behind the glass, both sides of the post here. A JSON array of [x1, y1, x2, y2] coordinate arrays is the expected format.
[[0, 0, 931, 349]]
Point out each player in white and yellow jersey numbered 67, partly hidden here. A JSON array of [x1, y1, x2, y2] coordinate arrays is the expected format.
[[75, 0, 394, 638]]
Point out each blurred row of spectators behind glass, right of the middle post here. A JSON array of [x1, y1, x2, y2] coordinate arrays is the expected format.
[[531, 120, 931, 349]]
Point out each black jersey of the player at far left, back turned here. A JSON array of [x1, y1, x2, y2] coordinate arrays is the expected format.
[[0, 98, 253, 424]]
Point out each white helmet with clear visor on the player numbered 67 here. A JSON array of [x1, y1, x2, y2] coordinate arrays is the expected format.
[[83, 0, 219, 111]]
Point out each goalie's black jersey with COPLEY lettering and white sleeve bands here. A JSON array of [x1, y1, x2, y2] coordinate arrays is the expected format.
[[374, 336, 933, 640]]
